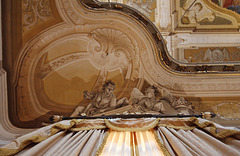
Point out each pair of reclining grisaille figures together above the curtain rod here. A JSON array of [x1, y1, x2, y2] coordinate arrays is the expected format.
[[70, 80, 193, 117]]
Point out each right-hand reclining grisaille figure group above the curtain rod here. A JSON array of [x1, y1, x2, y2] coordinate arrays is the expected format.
[[130, 85, 191, 115]]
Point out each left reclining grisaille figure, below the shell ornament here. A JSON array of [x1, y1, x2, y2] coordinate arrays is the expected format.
[[71, 81, 128, 117]]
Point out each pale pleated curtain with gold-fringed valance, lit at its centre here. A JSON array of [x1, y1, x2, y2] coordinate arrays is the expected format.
[[0, 118, 240, 156]]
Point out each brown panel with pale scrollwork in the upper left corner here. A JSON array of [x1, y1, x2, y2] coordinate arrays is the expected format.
[[22, 0, 52, 30]]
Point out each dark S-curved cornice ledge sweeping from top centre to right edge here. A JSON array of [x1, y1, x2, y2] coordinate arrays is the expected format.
[[80, 0, 240, 75]]
